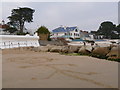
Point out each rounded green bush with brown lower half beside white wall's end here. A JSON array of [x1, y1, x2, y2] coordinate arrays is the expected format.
[[36, 26, 50, 40]]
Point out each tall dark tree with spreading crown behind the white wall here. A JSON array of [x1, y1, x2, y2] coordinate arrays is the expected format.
[[8, 7, 35, 33]]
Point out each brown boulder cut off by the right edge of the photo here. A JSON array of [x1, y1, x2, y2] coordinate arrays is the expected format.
[[107, 45, 120, 59]]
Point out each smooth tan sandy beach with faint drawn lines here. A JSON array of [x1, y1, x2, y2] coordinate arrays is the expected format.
[[2, 49, 118, 88]]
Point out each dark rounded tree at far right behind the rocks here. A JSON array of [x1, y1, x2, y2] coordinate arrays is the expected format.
[[97, 21, 116, 39]]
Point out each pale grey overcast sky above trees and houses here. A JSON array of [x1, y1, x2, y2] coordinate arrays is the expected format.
[[2, 2, 118, 31]]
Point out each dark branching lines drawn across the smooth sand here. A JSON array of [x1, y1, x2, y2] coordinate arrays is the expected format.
[[6, 54, 112, 88]]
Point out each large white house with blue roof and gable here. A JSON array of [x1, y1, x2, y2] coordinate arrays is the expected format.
[[50, 26, 80, 39]]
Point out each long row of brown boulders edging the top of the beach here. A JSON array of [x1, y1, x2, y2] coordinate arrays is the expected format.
[[20, 44, 120, 61]]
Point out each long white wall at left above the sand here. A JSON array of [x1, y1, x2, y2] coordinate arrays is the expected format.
[[0, 35, 39, 49]]
